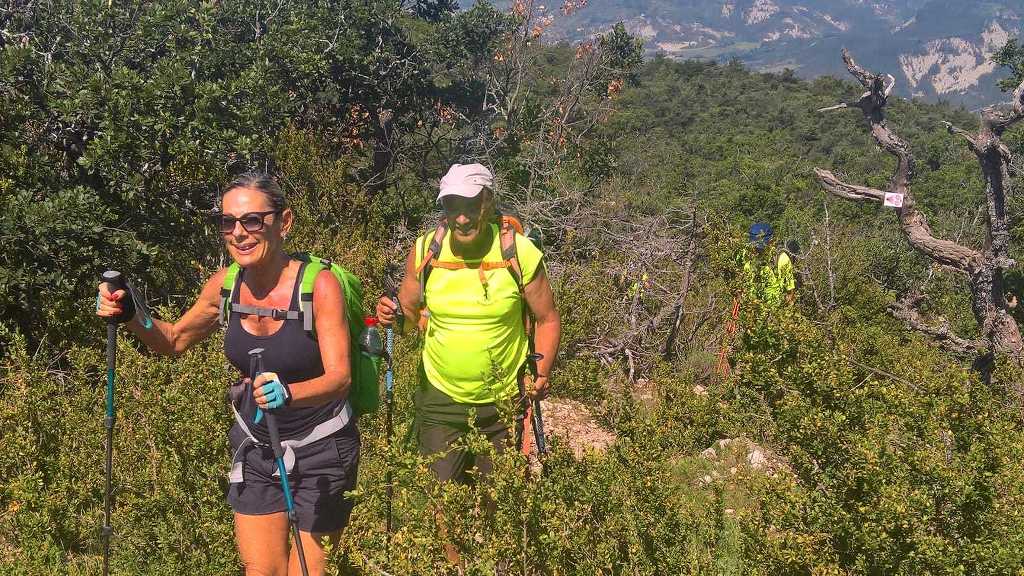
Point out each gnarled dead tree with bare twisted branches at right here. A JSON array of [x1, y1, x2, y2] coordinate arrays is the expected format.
[[815, 49, 1024, 362]]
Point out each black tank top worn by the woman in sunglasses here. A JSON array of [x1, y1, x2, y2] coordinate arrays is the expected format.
[[224, 262, 346, 442]]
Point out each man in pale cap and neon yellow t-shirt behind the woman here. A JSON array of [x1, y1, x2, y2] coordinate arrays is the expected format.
[[377, 164, 561, 482]]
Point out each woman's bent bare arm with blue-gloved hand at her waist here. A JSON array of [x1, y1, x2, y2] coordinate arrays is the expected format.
[[253, 270, 352, 409]]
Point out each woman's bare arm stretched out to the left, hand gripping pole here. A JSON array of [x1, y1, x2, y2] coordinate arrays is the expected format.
[[96, 269, 227, 356]]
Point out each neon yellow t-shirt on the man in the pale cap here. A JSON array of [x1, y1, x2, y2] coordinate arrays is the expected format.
[[416, 224, 543, 404]]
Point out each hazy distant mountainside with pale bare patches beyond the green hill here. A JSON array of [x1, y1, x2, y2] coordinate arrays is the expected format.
[[549, 0, 1024, 107]]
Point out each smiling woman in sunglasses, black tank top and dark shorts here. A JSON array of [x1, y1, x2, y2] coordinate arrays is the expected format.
[[96, 173, 359, 575]]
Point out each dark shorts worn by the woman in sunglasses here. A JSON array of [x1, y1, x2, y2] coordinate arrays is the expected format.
[[227, 421, 359, 533]]
